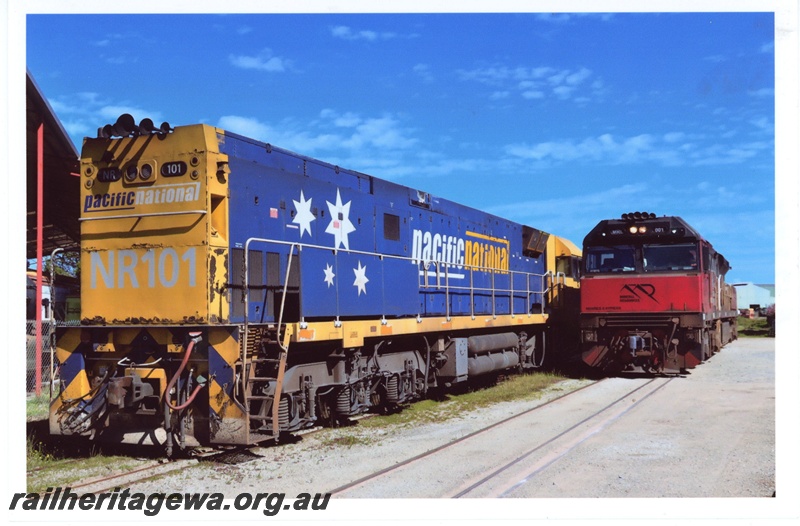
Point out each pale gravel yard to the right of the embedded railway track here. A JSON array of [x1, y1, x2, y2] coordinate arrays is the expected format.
[[511, 339, 775, 497]]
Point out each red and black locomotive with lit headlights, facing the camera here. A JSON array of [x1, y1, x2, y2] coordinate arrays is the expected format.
[[580, 212, 736, 374]]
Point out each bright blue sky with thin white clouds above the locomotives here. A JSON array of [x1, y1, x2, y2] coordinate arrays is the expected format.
[[26, 13, 776, 283]]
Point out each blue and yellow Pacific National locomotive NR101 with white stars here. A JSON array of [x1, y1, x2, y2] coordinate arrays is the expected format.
[[50, 116, 580, 458]]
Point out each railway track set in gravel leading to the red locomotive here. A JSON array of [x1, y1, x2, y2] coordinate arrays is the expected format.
[[330, 377, 674, 498]]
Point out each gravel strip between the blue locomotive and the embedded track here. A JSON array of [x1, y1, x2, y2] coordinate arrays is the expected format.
[[131, 380, 591, 497]]
